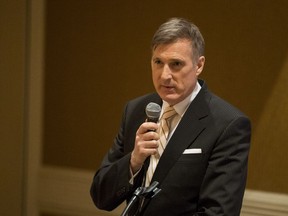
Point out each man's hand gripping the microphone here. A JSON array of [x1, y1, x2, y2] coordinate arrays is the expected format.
[[130, 122, 159, 173]]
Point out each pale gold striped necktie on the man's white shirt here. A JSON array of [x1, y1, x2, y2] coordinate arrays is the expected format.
[[145, 106, 177, 187]]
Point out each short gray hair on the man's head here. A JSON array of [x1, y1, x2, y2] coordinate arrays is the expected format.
[[151, 18, 205, 60]]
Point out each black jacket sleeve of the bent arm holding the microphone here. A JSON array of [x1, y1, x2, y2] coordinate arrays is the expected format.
[[90, 103, 141, 211]]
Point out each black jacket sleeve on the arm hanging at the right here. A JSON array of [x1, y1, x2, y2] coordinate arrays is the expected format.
[[195, 116, 251, 216]]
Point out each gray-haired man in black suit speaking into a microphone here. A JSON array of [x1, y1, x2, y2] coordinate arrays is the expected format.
[[91, 18, 251, 216]]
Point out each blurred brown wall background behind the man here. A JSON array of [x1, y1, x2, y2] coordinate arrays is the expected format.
[[0, 0, 288, 216]]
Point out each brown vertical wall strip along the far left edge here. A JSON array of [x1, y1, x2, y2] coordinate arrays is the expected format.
[[0, 0, 27, 216]]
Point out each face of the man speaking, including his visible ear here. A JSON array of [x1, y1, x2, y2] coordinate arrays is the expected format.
[[151, 39, 205, 106]]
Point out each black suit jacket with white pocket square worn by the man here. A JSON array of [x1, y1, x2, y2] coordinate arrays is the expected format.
[[91, 80, 251, 216]]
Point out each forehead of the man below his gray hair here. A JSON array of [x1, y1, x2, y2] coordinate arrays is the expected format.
[[152, 39, 193, 58]]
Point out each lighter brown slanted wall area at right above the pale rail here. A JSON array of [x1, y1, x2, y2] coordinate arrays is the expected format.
[[249, 56, 288, 193]]
